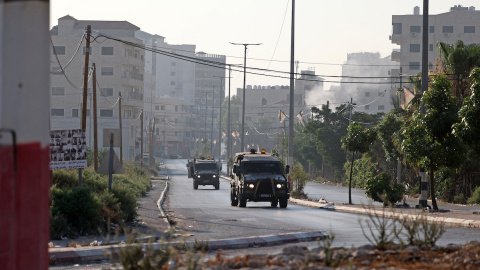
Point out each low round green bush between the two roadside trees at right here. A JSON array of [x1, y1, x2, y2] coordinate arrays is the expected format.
[[365, 172, 405, 206]]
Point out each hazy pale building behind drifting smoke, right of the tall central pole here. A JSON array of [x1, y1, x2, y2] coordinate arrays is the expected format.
[[340, 52, 399, 114]]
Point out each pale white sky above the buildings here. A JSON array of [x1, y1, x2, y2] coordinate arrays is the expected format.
[[50, 0, 480, 93]]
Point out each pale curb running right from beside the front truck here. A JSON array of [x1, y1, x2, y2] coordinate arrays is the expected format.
[[289, 198, 480, 228]]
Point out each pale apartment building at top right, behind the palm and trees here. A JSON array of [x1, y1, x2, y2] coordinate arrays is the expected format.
[[390, 5, 480, 76]]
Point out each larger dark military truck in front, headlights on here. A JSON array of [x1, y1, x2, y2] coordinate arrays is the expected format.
[[230, 149, 290, 208]]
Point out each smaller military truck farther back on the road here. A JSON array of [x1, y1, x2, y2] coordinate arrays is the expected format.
[[187, 158, 222, 189]]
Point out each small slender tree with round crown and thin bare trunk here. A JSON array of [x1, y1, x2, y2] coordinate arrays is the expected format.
[[342, 122, 377, 204]]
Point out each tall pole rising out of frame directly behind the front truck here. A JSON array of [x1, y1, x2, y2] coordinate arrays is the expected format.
[[287, 0, 295, 166]]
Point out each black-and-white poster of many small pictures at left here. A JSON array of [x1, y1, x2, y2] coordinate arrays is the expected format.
[[50, 129, 87, 170]]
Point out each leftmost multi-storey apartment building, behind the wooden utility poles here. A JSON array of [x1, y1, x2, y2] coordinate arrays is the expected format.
[[50, 15, 145, 161]]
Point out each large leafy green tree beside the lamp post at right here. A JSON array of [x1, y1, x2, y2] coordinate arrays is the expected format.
[[400, 75, 462, 210]]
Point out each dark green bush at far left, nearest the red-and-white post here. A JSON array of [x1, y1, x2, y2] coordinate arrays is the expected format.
[[50, 187, 101, 235]]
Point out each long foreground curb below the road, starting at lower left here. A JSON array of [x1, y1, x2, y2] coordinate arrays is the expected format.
[[49, 231, 328, 264]]
